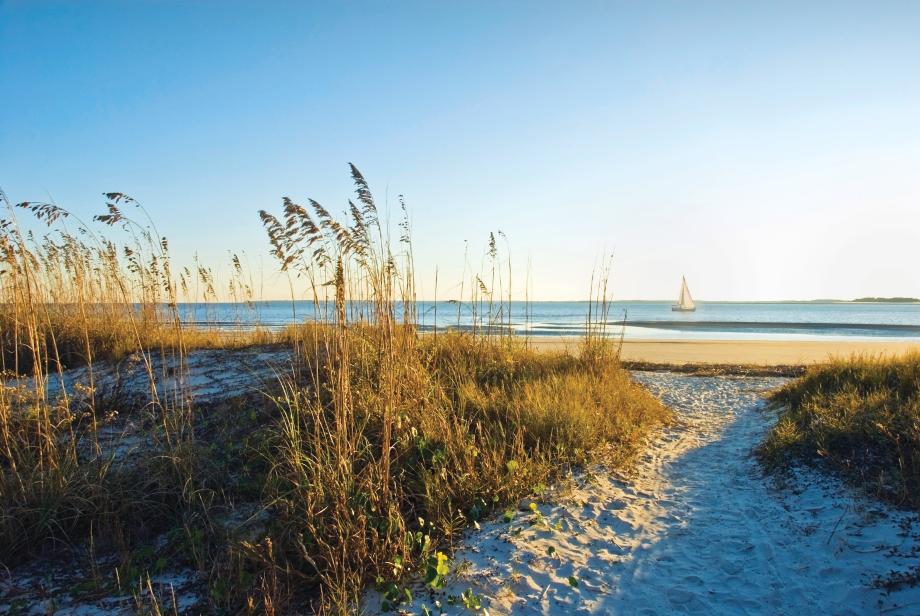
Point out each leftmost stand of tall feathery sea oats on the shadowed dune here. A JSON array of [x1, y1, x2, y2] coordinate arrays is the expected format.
[[0, 193, 252, 576]]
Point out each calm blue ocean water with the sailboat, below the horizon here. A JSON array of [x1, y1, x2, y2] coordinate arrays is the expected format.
[[181, 301, 920, 342]]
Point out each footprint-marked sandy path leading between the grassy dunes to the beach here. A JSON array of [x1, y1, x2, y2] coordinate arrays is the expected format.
[[368, 373, 920, 614]]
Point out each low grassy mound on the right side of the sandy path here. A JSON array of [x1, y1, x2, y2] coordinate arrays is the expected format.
[[759, 354, 920, 508]]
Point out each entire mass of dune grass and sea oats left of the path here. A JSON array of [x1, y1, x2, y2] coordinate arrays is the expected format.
[[0, 168, 668, 614]]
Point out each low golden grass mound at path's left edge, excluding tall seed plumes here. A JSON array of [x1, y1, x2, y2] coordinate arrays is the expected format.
[[250, 331, 667, 610]]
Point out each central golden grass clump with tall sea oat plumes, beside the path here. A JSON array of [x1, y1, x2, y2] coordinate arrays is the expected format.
[[244, 167, 666, 611]]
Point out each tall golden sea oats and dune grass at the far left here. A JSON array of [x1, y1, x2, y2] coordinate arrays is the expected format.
[[0, 186, 269, 612]]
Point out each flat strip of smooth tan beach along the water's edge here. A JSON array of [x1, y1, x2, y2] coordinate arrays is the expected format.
[[531, 336, 920, 366]]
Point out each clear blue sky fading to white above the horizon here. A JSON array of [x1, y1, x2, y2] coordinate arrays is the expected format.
[[0, 0, 920, 300]]
